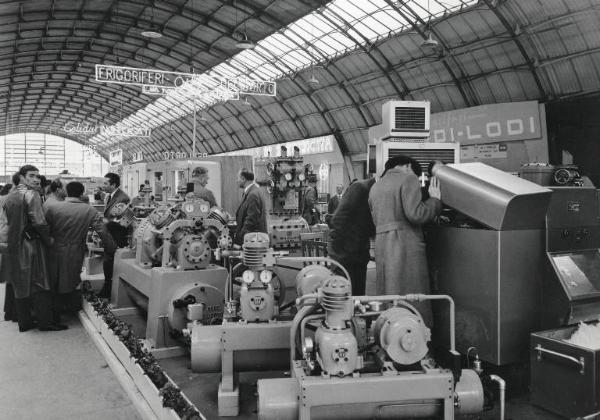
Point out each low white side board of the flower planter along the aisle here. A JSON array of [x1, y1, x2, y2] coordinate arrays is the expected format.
[[83, 299, 203, 420]]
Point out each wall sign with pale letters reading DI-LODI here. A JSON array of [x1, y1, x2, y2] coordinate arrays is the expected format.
[[430, 101, 545, 145]]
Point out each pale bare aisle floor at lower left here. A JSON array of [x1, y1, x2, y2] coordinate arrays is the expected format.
[[0, 284, 140, 420]]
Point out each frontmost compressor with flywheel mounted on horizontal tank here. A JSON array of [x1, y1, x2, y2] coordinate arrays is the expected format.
[[258, 273, 492, 420]]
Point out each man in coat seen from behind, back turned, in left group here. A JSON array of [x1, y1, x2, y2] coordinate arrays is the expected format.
[[46, 181, 104, 312]]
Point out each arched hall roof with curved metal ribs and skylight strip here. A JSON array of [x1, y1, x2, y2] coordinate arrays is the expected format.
[[0, 0, 600, 159]]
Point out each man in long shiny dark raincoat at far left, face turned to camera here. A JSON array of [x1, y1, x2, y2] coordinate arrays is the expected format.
[[2, 165, 67, 332]]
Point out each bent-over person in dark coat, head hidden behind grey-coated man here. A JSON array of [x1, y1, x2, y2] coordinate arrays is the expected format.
[[327, 178, 375, 296]]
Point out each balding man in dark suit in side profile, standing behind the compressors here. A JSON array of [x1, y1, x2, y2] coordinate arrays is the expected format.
[[234, 169, 267, 246]]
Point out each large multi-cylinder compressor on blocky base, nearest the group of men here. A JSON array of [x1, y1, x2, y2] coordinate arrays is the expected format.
[[111, 200, 231, 351]]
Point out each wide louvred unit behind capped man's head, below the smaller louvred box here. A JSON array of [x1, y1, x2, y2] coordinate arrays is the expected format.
[[367, 141, 460, 175]]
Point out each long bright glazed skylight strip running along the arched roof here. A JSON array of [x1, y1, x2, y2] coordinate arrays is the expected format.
[[90, 0, 478, 146]]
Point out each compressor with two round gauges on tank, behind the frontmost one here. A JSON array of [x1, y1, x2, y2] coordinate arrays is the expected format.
[[187, 232, 344, 416]]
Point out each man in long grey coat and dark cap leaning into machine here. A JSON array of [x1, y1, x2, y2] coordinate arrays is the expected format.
[[369, 156, 442, 326]]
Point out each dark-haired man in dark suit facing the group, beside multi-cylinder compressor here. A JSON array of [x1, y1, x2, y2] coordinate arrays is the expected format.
[[98, 172, 129, 298]]
